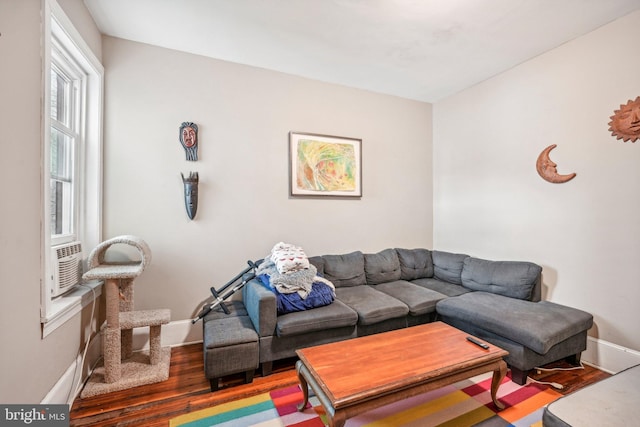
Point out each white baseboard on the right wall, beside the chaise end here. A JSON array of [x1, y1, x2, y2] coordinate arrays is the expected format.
[[582, 337, 640, 374]]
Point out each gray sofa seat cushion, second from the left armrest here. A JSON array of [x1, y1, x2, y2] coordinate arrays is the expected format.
[[336, 285, 409, 325]]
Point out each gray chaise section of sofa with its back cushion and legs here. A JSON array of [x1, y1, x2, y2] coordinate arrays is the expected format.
[[437, 257, 593, 384]]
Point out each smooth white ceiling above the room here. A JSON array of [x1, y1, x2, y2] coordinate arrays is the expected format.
[[85, 0, 640, 102]]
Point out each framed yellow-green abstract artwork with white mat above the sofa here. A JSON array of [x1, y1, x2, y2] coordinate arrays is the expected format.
[[289, 132, 362, 197]]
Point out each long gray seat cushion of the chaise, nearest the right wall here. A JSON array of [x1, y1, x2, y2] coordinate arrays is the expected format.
[[436, 291, 593, 354]]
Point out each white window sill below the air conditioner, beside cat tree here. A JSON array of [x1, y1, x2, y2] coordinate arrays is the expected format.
[[41, 280, 103, 338]]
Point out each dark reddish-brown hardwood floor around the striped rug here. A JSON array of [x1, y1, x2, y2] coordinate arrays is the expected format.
[[70, 344, 609, 427]]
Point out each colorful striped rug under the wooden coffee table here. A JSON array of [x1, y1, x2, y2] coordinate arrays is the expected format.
[[169, 374, 561, 427]]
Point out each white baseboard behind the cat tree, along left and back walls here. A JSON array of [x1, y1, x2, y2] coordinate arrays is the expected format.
[[41, 320, 204, 405]]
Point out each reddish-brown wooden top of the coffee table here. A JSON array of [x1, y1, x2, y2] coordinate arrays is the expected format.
[[296, 322, 508, 408]]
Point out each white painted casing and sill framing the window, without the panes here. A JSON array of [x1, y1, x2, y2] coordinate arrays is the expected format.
[[40, 0, 104, 338]]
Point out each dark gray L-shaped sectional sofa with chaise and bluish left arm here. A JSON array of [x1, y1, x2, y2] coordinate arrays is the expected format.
[[242, 249, 593, 384]]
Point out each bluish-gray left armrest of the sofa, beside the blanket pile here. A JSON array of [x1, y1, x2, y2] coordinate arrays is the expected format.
[[242, 279, 277, 337]]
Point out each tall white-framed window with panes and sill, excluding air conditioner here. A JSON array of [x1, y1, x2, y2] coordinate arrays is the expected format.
[[40, 0, 104, 336]]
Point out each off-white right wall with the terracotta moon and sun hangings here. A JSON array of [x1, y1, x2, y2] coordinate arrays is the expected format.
[[434, 12, 640, 358]]
